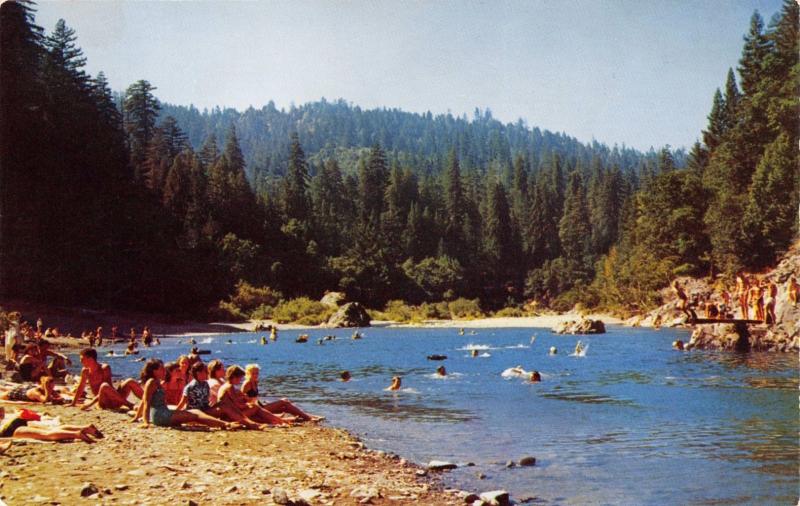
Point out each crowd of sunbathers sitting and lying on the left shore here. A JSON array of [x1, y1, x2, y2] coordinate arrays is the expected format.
[[0, 314, 322, 453]]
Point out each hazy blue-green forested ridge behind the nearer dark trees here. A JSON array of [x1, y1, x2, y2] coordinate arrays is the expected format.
[[155, 99, 686, 186]]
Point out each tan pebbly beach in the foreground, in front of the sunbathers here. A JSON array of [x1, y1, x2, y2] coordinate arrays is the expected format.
[[0, 402, 463, 506]]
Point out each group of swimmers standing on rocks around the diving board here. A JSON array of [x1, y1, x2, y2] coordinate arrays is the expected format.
[[672, 273, 800, 325]]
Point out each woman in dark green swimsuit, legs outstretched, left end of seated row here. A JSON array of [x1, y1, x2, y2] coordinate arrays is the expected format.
[[133, 358, 242, 429]]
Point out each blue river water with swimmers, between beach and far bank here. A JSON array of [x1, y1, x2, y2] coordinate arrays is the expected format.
[[83, 326, 800, 505]]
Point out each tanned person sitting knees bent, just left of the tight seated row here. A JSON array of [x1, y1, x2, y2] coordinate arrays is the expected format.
[[70, 348, 143, 409]]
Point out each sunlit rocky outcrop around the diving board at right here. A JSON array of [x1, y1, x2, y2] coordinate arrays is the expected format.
[[624, 242, 800, 353]]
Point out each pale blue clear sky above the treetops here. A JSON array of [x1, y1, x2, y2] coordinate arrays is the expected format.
[[36, 0, 781, 149]]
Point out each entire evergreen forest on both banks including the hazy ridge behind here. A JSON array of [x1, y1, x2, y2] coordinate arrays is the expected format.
[[0, 0, 800, 316]]
